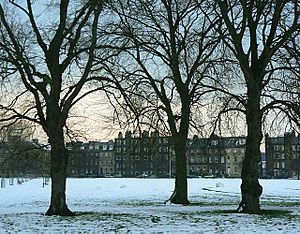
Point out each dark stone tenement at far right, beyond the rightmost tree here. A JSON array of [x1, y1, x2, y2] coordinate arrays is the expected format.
[[265, 132, 300, 179]]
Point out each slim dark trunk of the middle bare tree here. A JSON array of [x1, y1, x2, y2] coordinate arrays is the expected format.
[[170, 136, 190, 204]]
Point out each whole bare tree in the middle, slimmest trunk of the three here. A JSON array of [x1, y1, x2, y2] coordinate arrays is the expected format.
[[112, 0, 218, 204]]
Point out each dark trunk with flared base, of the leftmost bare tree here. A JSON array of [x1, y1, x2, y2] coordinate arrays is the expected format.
[[46, 130, 74, 216]]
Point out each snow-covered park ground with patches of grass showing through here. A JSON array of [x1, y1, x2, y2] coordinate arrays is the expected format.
[[0, 178, 300, 233]]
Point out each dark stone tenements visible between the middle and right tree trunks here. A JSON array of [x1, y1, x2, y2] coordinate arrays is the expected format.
[[187, 136, 246, 177]]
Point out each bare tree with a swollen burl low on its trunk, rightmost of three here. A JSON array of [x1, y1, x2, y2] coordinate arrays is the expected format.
[[217, 0, 300, 213]]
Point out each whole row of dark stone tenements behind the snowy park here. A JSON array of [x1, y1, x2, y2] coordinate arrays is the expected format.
[[67, 131, 300, 178]]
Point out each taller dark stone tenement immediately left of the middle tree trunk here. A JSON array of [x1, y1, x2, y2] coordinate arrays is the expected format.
[[115, 131, 175, 177]]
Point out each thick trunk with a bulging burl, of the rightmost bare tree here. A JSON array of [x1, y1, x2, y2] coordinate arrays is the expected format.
[[238, 82, 262, 213]]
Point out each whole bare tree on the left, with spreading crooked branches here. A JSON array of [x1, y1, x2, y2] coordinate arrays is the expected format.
[[0, 0, 108, 215]]
